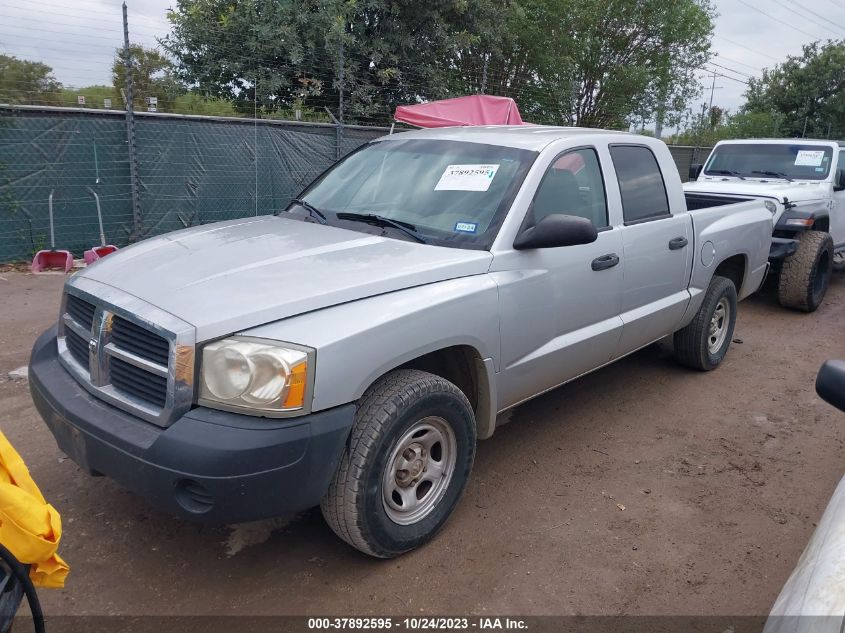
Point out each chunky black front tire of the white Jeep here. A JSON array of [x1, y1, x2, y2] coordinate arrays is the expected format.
[[778, 231, 833, 312]]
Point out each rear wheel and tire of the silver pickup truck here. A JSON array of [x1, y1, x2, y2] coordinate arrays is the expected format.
[[674, 276, 737, 371]]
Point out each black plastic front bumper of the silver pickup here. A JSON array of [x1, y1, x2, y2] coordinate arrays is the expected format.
[[29, 328, 355, 524]]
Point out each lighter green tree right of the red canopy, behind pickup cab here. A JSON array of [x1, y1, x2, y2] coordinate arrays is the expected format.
[[516, 0, 714, 127]]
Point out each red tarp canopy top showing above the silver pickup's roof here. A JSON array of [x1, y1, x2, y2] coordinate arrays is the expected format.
[[393, 95, 525, 127]]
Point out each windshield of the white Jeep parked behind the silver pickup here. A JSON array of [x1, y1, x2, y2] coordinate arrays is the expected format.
[[704, 143, 833, 180]]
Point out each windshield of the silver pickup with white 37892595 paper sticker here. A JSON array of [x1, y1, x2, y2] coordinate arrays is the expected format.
[[288, 139, 537, 249]]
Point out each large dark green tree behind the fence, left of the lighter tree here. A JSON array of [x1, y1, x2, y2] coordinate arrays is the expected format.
[[161, 0, 508, 122]]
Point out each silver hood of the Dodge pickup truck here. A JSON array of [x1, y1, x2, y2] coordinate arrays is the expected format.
[[78, 216, 492, 342]]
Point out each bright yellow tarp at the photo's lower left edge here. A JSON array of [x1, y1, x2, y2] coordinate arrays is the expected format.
[[0, 431, 69, 587]]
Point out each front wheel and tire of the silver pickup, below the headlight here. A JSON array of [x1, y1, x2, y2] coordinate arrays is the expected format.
[[320, 369, 476, 558]]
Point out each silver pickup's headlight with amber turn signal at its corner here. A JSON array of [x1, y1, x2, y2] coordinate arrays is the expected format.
[[199, 338, 313, 415]]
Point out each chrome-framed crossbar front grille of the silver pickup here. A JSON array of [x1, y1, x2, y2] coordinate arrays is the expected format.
[[58, 277, 194, 426]]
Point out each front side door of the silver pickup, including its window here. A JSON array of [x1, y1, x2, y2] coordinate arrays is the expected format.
[[490, 147, 623, 408]]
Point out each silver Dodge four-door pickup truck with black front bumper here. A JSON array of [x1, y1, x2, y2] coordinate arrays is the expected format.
[[30, 126, 776, 557]]
